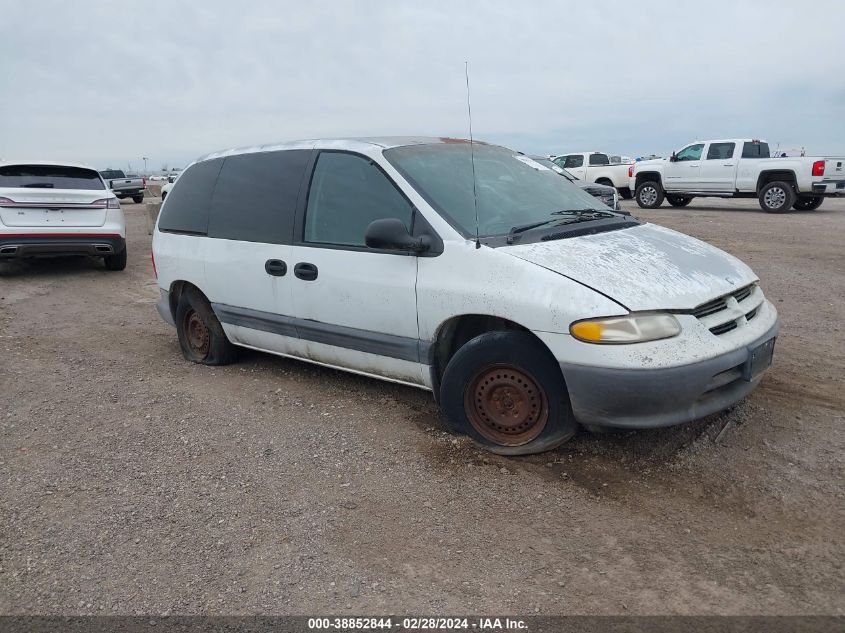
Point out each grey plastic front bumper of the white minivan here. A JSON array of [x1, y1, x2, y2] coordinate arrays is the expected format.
[[560, 321, 780, 428]]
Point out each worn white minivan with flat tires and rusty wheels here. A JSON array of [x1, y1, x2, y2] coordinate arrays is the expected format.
[[153, 138, 778, 455]]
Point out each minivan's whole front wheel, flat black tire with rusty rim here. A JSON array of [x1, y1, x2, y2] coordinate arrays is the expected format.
[[440, 332, 578, 455]]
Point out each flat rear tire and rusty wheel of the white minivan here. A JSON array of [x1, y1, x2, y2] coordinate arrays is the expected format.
[[176, 288, 238, 365]]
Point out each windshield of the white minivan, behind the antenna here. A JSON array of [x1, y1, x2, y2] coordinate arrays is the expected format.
[[384, 141, 622, 237]]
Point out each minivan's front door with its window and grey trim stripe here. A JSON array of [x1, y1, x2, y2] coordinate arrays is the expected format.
[[291, 151, 424, 385]]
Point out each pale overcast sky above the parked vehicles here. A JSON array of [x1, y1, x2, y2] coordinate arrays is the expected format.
[[0, 0, 845, 170]]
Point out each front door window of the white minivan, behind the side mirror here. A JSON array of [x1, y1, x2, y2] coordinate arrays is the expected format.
[[305, 152, 413, 246]]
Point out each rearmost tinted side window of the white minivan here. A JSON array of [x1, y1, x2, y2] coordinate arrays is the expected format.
[[158, 158, 223, 235]]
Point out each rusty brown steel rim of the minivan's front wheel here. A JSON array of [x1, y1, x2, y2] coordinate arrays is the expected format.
[[464, 365, 549, 446]]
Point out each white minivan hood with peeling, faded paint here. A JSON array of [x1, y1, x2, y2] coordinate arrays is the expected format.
[[496, 224, 757, 311]]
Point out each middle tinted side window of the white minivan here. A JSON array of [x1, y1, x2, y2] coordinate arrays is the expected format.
[[207, 150, 311, 244]]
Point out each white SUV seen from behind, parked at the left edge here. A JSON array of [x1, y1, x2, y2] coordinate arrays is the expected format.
[[0, 161, 126, 270]]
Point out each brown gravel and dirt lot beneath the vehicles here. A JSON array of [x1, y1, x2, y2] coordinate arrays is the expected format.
[[0, 195, 845, 615]]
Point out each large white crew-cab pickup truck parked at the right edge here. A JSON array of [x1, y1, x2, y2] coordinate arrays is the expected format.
[[629, 139, 845, 213]]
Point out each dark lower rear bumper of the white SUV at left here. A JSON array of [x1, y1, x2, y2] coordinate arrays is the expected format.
[[0, 233, 126, 259]]
